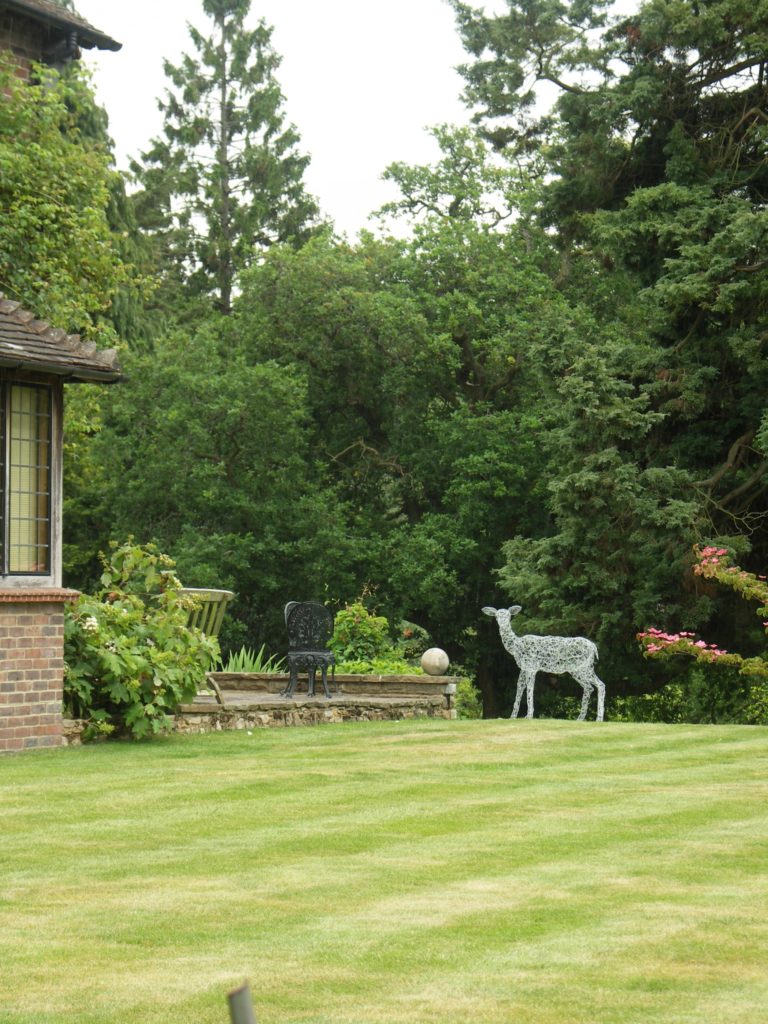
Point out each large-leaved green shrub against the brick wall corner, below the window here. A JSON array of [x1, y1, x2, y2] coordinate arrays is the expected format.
[[65, 540, 219, 738]]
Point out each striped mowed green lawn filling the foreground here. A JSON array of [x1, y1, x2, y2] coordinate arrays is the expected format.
[[0, 721, 768, 1024]]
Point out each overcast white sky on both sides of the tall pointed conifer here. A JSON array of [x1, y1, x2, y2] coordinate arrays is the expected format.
[[72, 0, 506, 237]]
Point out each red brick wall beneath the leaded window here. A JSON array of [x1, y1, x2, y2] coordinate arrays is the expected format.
[[0, 589, 77, 752]]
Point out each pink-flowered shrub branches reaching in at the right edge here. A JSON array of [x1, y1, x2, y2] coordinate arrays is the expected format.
[[637, 547, 768, 680]]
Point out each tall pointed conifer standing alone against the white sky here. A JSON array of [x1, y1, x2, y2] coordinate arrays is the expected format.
[[134, 0, 318, 313]]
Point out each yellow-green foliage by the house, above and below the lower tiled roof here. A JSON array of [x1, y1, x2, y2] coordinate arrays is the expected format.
[[0, 61, 148, 585]]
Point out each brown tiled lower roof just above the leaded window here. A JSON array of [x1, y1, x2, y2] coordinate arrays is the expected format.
[[0, 292, 123, 384]]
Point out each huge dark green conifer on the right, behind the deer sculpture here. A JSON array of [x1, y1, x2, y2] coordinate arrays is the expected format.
[[444, 0, 768, 704]]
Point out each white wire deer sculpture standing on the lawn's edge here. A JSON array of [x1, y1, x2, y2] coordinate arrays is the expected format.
[[482, 604, 605, 722]]
